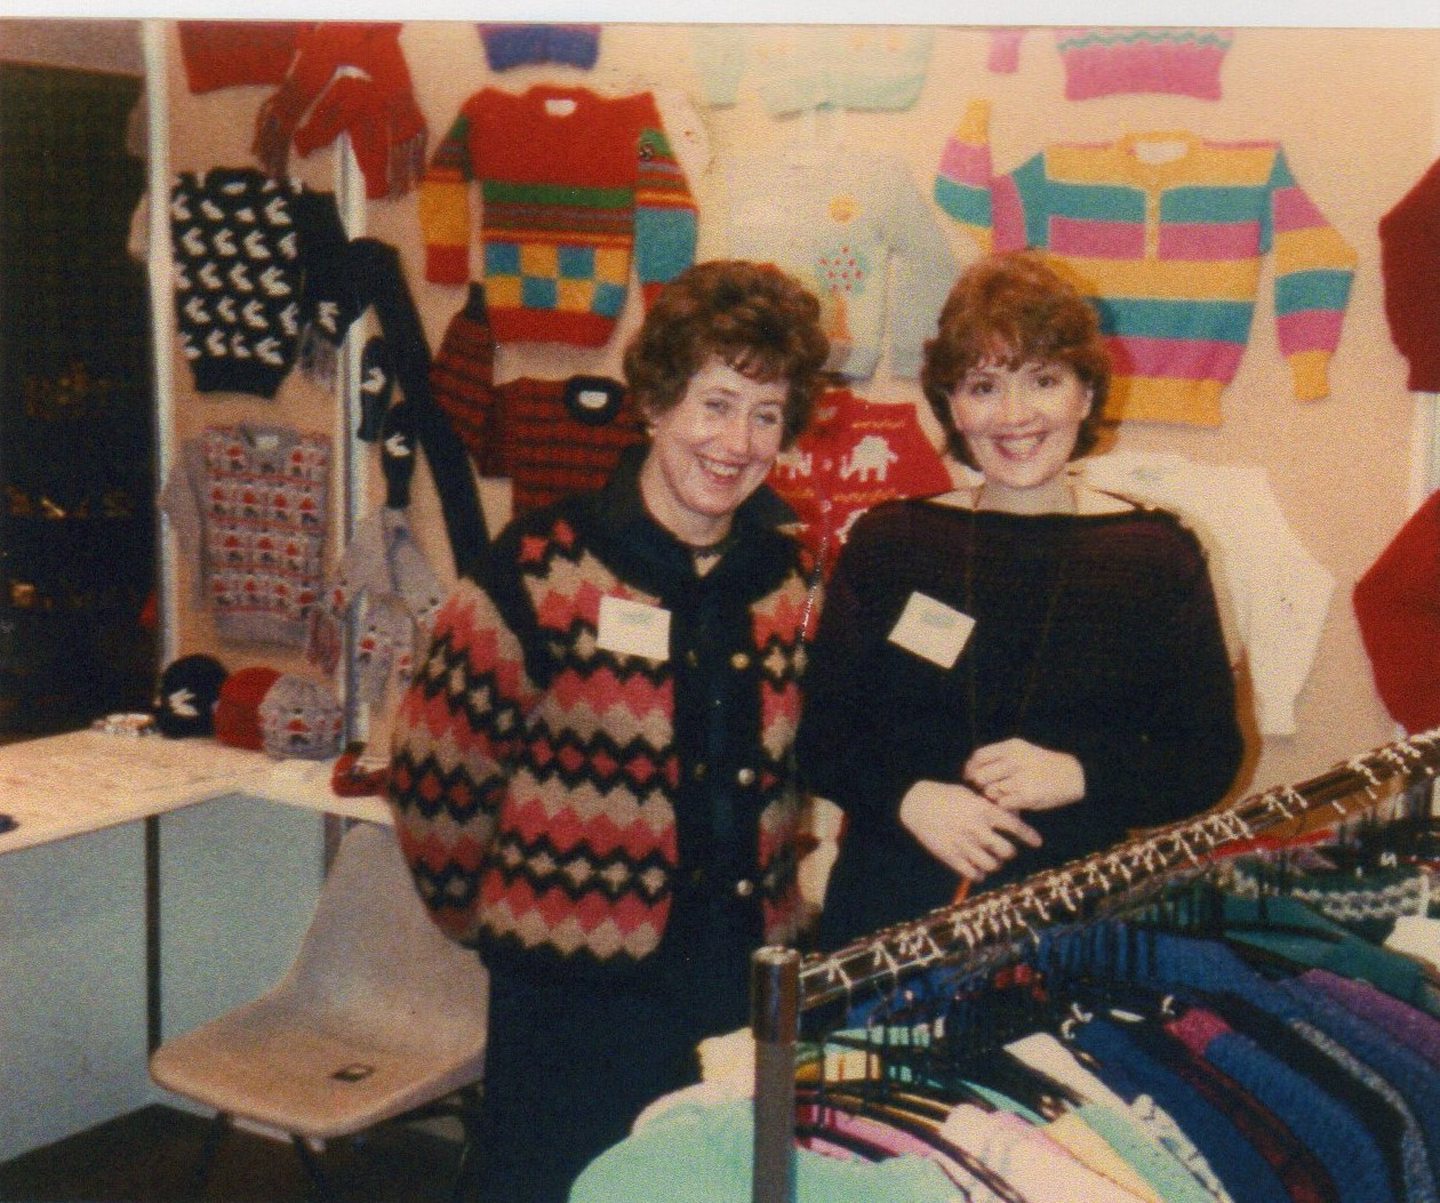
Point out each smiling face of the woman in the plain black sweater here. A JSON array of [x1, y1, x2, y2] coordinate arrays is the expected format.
[[950, 360, 1092, 491]]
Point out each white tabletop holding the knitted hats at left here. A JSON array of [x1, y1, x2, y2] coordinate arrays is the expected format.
[[0, 730, 390, 853]]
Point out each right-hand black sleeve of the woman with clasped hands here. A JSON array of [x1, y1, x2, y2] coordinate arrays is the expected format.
[[1068, 527, 1244, 843]]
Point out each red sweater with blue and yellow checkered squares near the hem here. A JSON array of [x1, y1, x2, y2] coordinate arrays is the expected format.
[[419, 85, 696, 346]]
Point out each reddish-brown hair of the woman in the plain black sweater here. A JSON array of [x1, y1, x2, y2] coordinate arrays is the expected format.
[[920, 251, 1110, 468]]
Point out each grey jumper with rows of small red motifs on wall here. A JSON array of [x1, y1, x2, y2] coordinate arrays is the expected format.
[[160, 425, 330, 647]]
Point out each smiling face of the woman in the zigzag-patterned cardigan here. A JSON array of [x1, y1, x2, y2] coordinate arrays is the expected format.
[[641, 356, 788, 543]]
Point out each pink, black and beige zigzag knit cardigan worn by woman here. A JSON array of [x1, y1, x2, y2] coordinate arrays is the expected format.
[[389, 475, 808, 971]]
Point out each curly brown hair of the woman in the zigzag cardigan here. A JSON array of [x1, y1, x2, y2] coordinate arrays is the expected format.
[[625, 259, 829, 447]]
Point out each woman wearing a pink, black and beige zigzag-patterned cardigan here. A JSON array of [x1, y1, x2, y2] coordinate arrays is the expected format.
[[389, 261, 828, 1203]]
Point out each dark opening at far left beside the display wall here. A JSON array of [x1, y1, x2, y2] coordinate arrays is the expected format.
[[0, 62, 157, 736]]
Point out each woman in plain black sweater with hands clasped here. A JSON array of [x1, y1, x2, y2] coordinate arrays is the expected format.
[[796, 252, 1243, 948]]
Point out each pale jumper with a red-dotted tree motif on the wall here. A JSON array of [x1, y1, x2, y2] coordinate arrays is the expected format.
[[726, 146, 956, 379]]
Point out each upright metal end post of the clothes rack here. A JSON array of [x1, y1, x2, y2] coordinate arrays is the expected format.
[[750, 945, 801, 1203]]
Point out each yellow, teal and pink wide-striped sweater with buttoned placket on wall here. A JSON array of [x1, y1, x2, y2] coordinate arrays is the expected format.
[[935, 101, 1355, 426]]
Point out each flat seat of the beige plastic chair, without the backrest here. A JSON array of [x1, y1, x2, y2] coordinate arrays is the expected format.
[[150, 1000, 485, 1140]]
